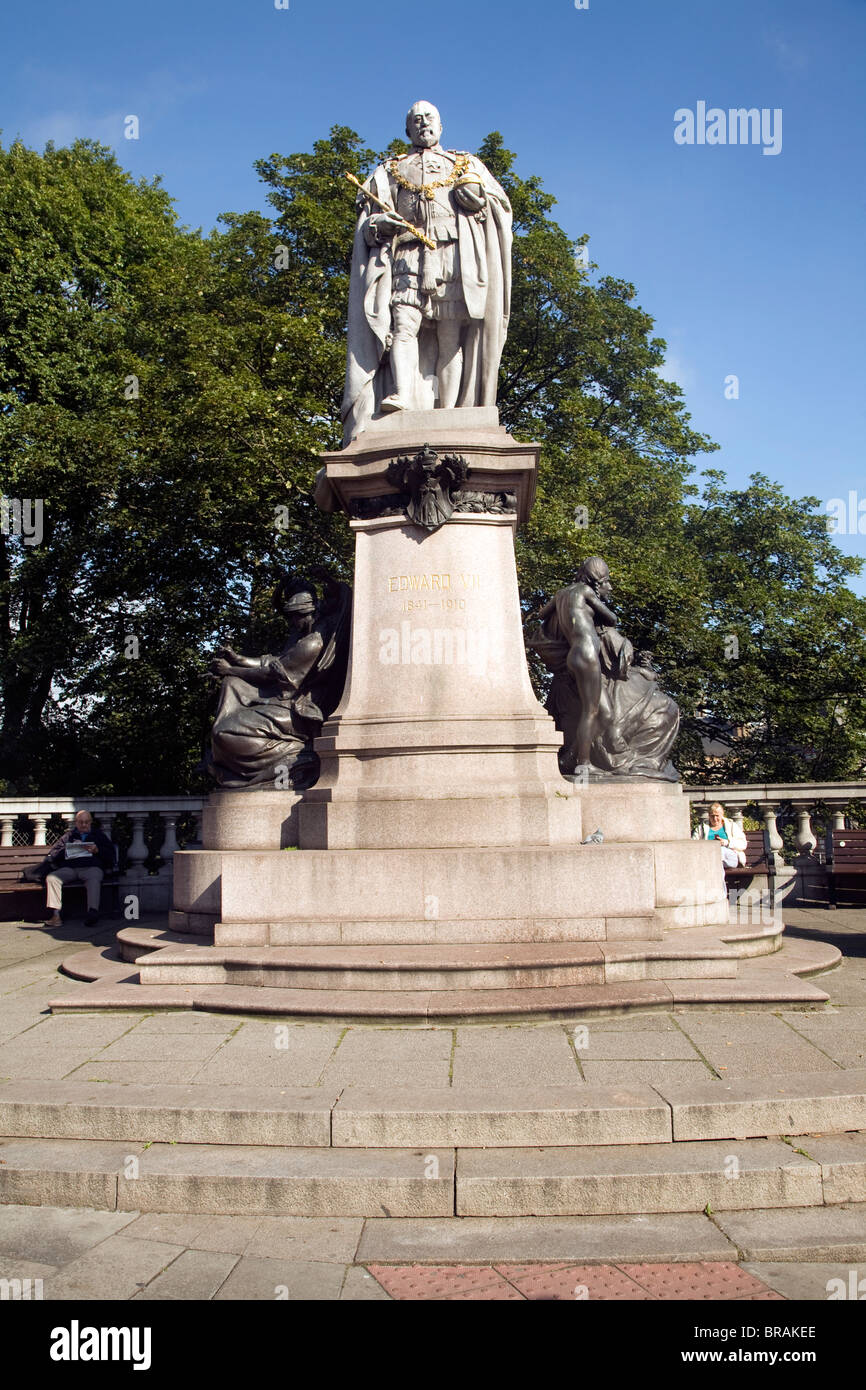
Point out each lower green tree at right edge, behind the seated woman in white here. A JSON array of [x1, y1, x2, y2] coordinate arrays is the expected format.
[[685, 470, 866, 781]]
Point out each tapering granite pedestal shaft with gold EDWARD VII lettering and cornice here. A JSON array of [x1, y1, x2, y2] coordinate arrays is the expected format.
[[300, 410, 569, 849]]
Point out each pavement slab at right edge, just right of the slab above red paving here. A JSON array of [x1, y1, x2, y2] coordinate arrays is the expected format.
[[716, 1204, 866, 1264]]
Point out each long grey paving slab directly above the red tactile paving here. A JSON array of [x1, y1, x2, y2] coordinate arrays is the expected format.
[[356, 1212, 737, 1264]]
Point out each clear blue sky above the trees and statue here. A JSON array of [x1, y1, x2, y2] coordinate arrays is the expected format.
[[0, 0, 866, 594]]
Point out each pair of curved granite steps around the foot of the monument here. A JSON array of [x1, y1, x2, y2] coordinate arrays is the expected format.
[[50, 927, 841, 1023]]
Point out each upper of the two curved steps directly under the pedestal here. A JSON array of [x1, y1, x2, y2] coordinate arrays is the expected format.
[[139, 941, 737, 991]]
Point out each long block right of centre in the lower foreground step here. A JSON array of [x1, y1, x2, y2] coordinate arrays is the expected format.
[[456, 1140, 823, 1216]]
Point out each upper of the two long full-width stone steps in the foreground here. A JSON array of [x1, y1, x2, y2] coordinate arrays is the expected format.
[[0, 1067, 866, 1152]]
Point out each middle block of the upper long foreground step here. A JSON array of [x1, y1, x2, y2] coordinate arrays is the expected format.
[[332, 1083, 670, 1148]]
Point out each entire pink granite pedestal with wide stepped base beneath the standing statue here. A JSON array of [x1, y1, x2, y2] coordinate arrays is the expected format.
[[170, 410, 739, 1016]]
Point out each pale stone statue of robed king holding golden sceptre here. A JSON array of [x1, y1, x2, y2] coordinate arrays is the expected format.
[[343, 101, 512, 445]]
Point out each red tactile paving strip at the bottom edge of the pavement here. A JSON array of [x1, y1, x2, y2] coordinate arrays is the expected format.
[[367, 1261, 784, 1302]]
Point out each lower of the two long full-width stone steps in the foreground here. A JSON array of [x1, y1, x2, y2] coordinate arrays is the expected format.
[[0, 1134, 866, 1216]]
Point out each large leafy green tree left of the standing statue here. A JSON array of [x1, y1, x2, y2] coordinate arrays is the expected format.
[[0, 142, 345, 791]]
